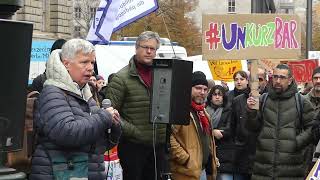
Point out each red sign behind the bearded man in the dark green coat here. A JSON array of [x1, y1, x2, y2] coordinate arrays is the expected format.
[[288, 59, 318, 83]]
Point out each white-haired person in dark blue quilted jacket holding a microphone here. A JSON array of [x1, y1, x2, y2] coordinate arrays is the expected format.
[[29, 39, 121, 180]]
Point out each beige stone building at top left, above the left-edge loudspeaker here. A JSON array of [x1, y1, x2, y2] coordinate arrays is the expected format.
[[12, 0, 72, 40]]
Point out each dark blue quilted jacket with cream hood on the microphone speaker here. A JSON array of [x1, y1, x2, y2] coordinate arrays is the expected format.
[[29, 50, 121, 180]]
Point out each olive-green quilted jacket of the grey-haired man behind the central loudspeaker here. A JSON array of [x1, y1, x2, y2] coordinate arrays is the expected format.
[[106, 56, 166, 147]]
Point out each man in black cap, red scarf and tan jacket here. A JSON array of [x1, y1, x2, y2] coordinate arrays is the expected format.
[[170, 71, 218, 180]]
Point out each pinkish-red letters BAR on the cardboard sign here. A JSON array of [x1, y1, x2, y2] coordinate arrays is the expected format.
[[274, 17, 299, 49]]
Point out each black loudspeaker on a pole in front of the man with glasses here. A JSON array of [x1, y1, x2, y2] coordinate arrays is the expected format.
[[150, 59, 193, 125]]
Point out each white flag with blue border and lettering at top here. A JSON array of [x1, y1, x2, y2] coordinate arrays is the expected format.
[[87, 0, 158, 44]]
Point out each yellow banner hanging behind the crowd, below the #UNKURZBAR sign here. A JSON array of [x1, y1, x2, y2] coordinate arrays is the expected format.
[[208, 60, 242, 82]]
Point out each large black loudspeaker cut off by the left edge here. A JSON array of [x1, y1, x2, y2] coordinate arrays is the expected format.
[[0, 19, 33, 151]]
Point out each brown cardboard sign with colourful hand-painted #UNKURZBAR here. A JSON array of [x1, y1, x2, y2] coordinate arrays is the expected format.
[[202, 14, 301, 60]]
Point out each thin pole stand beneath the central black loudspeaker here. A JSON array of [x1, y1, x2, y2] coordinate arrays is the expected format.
[[161, 124, 172, 180]]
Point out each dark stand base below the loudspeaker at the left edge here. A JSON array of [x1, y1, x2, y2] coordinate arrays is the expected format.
[[0, 152, 27, 180]]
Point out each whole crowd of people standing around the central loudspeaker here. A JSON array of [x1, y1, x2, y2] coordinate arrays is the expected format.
[[19, 31, 320, 180]]
